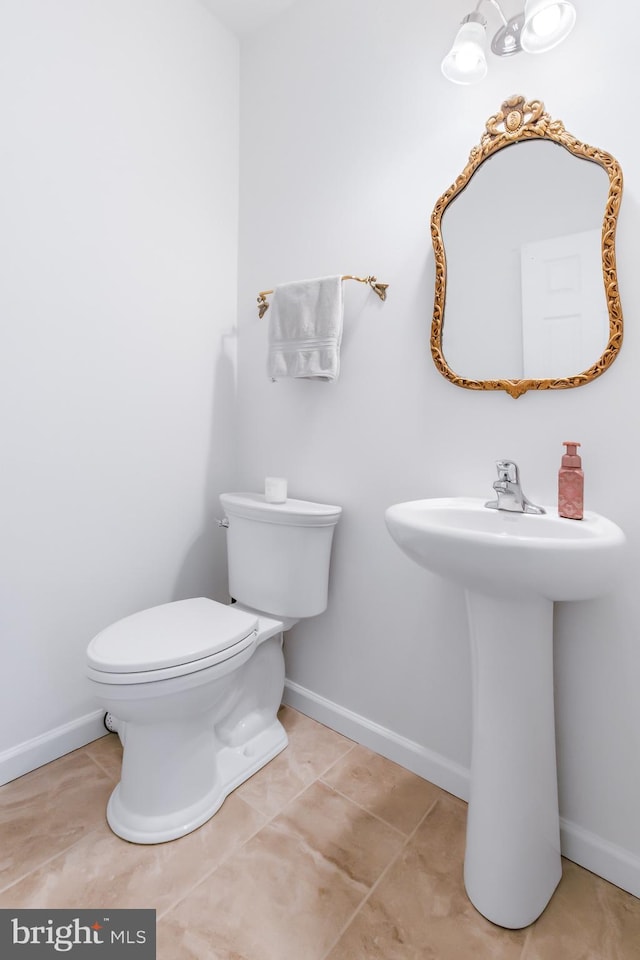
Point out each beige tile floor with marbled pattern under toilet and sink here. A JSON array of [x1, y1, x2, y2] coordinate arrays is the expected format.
[[0, 707, 640, 960]]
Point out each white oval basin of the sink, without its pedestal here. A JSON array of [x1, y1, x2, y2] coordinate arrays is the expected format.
[[386, 497, 624, 600]]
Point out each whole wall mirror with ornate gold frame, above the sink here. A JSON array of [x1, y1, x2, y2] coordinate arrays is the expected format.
[[431, 96, 622, 397]]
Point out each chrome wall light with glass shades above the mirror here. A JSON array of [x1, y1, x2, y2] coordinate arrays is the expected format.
[[442, 0, 576, 84]]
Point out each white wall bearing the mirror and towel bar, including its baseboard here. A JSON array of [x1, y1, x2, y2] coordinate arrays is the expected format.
[[238, 0, 640, 893]]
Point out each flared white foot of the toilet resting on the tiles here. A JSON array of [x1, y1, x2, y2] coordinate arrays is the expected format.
[[107, 720, 288, 843]]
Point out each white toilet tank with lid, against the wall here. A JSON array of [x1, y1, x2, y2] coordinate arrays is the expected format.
[[220, 493, 342, 619]]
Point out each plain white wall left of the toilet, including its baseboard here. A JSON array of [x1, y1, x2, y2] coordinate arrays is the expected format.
[[0, 0, 238, 779]]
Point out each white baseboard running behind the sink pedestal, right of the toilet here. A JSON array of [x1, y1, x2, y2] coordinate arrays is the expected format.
[[283, 680, 640, 897]]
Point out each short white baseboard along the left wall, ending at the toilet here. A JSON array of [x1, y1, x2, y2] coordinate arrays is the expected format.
[[0, 710, 106, 784]]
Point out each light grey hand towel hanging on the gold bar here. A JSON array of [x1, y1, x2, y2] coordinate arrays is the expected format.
[[268, 276, 343, 380]]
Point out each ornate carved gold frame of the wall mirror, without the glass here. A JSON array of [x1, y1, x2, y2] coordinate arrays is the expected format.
[[431, 96, 622, 398]]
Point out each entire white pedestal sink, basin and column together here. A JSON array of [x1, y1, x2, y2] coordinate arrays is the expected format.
[[385, 497, 625, 928]]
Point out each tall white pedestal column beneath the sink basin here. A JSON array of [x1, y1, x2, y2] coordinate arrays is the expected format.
[[464, 590, 562, 928]]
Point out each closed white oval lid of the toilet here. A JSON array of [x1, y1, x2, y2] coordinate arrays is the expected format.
[[87, 597, 258, 673]]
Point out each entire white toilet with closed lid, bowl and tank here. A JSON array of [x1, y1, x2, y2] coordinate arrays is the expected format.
[[87, 493, 341, 843]]
